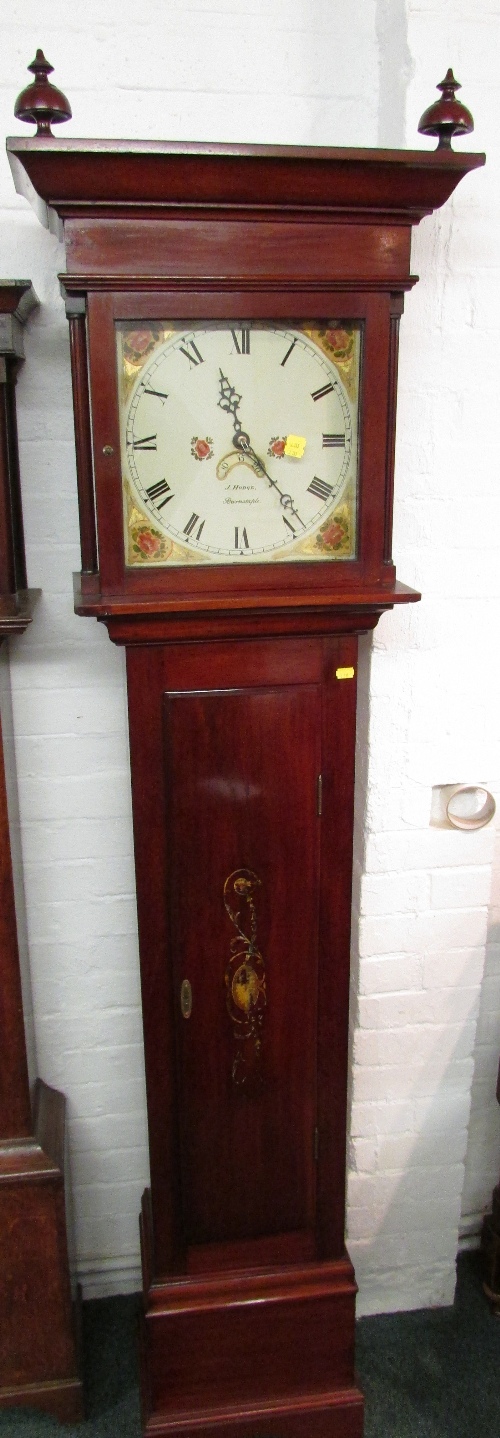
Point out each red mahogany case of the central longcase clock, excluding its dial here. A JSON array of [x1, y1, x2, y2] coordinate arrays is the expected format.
[[7, 56, 484, 1438]]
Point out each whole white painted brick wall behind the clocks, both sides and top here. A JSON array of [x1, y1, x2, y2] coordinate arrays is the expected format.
[[0, 0, 500, 1311]]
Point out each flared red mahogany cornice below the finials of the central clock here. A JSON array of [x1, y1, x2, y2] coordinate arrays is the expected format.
[[7, 137, 486, 224]]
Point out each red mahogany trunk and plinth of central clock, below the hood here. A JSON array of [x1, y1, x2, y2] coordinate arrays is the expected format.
[[128, 636, 362, 1438]]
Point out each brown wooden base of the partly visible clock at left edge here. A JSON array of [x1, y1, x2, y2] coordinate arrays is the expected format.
[[0, 1080, 83, 1422]]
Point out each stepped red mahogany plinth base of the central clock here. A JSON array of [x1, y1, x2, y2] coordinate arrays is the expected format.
[[141, 1191, 364, 1438]]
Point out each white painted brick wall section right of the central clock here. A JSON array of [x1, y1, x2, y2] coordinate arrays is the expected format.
[[348, 0, 500, 1311]]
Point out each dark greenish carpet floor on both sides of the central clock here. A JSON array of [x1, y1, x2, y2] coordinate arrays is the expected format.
[[0, 1254, 500, 1438]]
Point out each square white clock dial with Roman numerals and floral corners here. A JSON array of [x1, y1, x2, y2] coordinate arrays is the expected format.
[[116, 321, 361, 567]]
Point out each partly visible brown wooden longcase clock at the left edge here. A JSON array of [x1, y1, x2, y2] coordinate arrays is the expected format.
[[0, 280, 83, 1422]]
